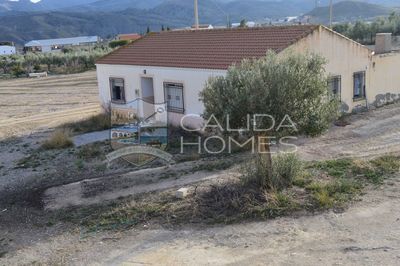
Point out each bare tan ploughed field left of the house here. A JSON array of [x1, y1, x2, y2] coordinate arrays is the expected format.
[[0, 71, 100, 139]]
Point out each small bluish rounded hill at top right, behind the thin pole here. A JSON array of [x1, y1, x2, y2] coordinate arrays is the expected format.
[[306, 1, 394, 23]]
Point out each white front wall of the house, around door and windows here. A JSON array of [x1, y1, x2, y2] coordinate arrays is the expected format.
[[97, 64, 227, 122]]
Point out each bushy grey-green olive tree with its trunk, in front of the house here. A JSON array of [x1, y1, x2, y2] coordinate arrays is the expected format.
[[200, 52, 338, 188]]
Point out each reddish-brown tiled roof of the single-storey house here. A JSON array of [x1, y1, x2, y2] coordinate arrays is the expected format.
[[97, 25, 318, 69]]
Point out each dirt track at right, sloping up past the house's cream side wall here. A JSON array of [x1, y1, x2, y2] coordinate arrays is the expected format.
[[298, 104, 400, 160]]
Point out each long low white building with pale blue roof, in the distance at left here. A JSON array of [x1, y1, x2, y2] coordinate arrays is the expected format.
[[24, 36, 100, 53]]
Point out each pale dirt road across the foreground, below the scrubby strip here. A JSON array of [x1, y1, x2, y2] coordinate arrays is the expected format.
[[71, 176, 400, 265]]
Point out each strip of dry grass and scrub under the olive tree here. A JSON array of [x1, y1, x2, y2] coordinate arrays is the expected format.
[[56, 156, 400, 230]]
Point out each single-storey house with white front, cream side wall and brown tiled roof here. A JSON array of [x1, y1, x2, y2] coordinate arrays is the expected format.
[[97, 25, 400, 123]]
